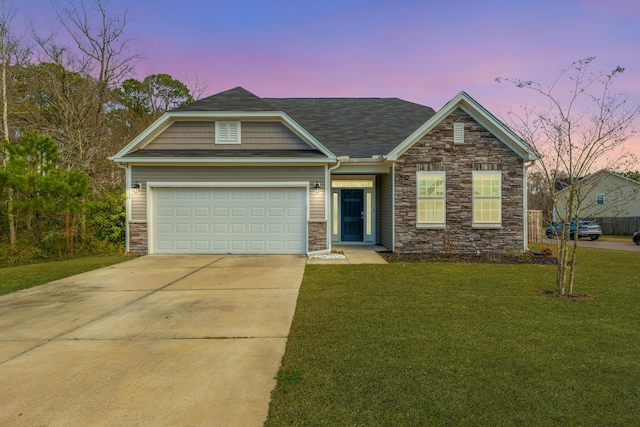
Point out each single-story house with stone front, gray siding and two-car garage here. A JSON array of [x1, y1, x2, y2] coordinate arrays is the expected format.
[[113, 87, 535, 254]]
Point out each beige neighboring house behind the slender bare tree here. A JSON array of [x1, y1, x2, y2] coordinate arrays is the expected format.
[[553, 170, 640, 234]]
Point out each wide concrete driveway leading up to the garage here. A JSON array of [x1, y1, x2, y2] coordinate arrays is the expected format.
[[0, 255, 306, 426]]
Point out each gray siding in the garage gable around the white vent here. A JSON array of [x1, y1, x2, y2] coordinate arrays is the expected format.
[[145, 121, 309, 150]]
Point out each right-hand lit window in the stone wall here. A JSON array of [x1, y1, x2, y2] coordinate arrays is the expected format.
[[473, 171, 502, 227]]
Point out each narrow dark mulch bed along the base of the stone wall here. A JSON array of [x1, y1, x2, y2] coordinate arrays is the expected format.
[[378, 252, 558, 265]]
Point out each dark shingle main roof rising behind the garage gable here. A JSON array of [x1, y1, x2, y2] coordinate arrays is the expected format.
[[174, 87, 435, 158]]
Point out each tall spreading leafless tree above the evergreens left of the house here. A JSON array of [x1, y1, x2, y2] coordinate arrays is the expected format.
[[23, 0, 140, 191]]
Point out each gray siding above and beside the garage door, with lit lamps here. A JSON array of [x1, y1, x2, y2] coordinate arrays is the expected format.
[[131, 166, 325, 221]]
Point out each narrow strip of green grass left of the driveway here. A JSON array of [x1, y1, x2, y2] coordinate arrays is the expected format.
[[0, 255, 131, 295]]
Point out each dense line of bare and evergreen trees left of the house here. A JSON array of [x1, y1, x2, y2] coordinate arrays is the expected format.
[[0, 0, 200, 264]]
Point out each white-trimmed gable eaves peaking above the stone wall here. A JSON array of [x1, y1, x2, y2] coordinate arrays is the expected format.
[[388, 92, 538, 160]]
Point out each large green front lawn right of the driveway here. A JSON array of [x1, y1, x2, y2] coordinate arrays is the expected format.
[[266, 248, 640, 426]]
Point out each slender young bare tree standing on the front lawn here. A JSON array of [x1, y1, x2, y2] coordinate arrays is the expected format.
[[496, 57, 640, 295]]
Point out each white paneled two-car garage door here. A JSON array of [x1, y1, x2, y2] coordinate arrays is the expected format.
[[152, 188, 307, 254]]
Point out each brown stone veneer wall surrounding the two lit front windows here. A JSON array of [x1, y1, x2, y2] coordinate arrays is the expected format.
[[395, 108, 524, 254]]
